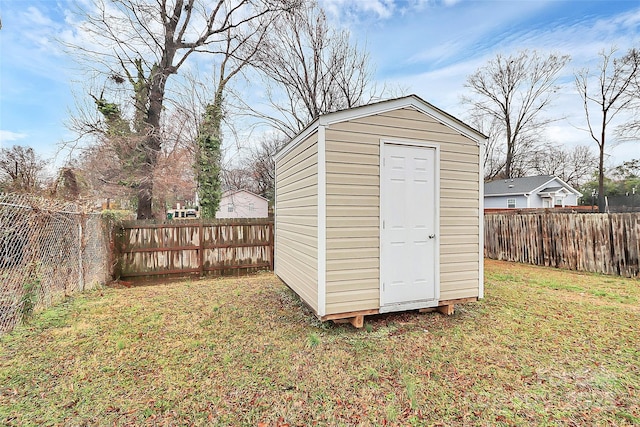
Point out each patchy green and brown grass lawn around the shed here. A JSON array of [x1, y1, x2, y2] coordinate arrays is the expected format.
[[0, 261, 640, 426]]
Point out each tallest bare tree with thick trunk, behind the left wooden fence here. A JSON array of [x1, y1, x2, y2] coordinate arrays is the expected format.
[[67, 0, 288, 219]]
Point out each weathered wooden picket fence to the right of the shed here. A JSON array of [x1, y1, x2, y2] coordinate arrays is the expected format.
[[484, 213, 640, 277]]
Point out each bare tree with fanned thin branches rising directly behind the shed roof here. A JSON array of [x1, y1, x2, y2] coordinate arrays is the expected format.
[[245, 1, 379, 137]]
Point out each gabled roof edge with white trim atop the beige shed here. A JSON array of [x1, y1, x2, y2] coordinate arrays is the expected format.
[[275, 95, 487, 163]]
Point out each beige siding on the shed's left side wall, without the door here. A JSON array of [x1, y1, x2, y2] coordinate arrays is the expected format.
[[275, 133, 318, 312]]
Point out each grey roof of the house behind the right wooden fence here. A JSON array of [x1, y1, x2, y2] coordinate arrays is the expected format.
[[484, 175, 582, 197]]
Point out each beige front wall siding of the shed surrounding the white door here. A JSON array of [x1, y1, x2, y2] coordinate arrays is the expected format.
[[326, 108, 480, 314]]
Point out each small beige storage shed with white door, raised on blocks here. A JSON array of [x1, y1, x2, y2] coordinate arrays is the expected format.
[[275, 95, 486, 327]]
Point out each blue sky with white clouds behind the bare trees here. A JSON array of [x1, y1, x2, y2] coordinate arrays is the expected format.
[[0, 0, 640, 171]]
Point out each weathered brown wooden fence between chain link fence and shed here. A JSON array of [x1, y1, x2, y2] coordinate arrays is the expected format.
[[116, 218, 273, 278]]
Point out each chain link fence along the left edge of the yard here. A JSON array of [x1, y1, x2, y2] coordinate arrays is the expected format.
[[0, 193, 111, 335]]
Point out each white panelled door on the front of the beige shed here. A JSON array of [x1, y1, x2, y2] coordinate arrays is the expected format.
[[380, 144, 438, 309]]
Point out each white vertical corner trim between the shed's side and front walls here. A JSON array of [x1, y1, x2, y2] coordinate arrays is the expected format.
[[317, 125, 327, 316]]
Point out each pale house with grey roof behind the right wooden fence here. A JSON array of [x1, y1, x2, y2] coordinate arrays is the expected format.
[[484, 175, 582, 209]]
